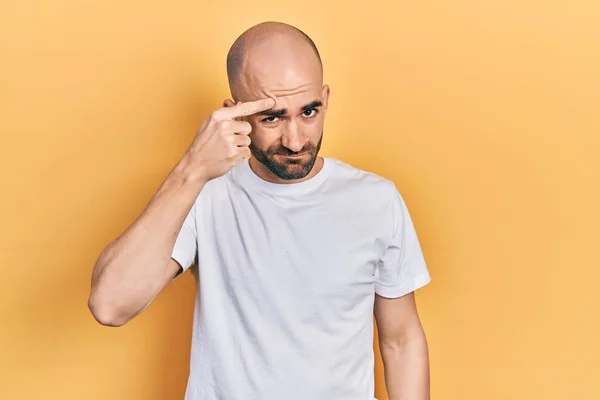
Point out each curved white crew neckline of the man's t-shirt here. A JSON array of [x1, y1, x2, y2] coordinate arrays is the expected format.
[[239, 157, 333, 195]]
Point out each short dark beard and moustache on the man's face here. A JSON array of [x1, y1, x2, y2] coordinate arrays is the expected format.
[[248, 132, 323, 180]]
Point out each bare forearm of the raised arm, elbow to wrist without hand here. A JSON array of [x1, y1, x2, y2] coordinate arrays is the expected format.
[[89, 155, 204, 325]]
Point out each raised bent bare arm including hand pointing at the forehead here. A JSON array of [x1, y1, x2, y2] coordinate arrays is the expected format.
[[88, 98, 275, 326]]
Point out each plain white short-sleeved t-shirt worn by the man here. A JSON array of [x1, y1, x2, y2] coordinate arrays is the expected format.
[[172, 158, 430, 400]]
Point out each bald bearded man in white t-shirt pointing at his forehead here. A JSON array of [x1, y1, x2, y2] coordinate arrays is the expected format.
[[89, 22, 430, 400]]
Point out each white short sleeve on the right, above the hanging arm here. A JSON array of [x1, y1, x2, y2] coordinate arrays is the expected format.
[[375, 187, 431, 298]]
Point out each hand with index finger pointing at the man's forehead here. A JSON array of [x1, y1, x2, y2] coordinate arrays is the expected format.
[[184, 98, 275, 182]]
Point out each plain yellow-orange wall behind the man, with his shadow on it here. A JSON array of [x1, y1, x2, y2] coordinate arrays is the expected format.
[[0, 0, 600, 400]]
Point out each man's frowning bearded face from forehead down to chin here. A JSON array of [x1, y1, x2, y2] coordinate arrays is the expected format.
[[247, 85, 329, 180]]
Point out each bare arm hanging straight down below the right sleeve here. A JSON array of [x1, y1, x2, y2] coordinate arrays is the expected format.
[[374, 292, 430, 400]]
